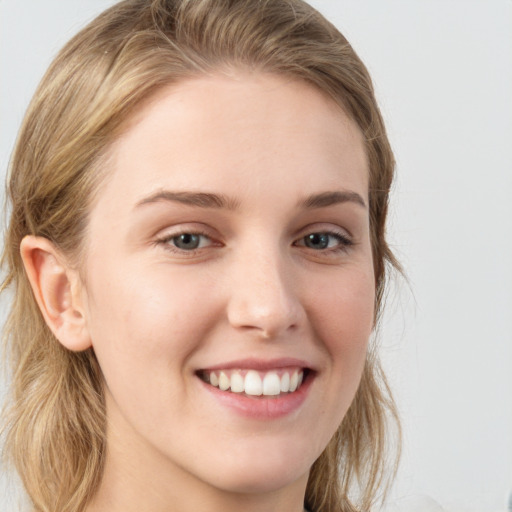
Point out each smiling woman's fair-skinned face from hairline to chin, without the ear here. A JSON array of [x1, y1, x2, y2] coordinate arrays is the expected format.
[[84, 73, 375, 493]]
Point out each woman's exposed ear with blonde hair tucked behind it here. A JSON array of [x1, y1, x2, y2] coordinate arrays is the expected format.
[[20, 236, 91, 351]]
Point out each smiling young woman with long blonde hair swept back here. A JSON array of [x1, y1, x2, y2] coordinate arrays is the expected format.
[[3, 0, 396, 512]]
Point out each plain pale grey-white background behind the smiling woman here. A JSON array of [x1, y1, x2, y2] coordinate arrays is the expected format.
[[0, 0, 512, 512]]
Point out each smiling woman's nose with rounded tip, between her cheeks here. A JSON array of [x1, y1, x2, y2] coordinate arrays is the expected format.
[[227, 246, 305, 339]]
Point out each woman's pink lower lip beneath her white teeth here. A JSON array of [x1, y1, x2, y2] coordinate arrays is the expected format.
[[198, 372, 314, 420]]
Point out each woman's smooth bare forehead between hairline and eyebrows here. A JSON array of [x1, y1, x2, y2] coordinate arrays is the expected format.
[[96, 73, 368, 209]]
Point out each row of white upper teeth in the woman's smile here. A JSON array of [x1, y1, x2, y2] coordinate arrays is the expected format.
[[204, 369, 304, 396]]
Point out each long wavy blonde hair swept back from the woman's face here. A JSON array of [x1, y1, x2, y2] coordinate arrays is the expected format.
[[2, 0, 398, 512]]
